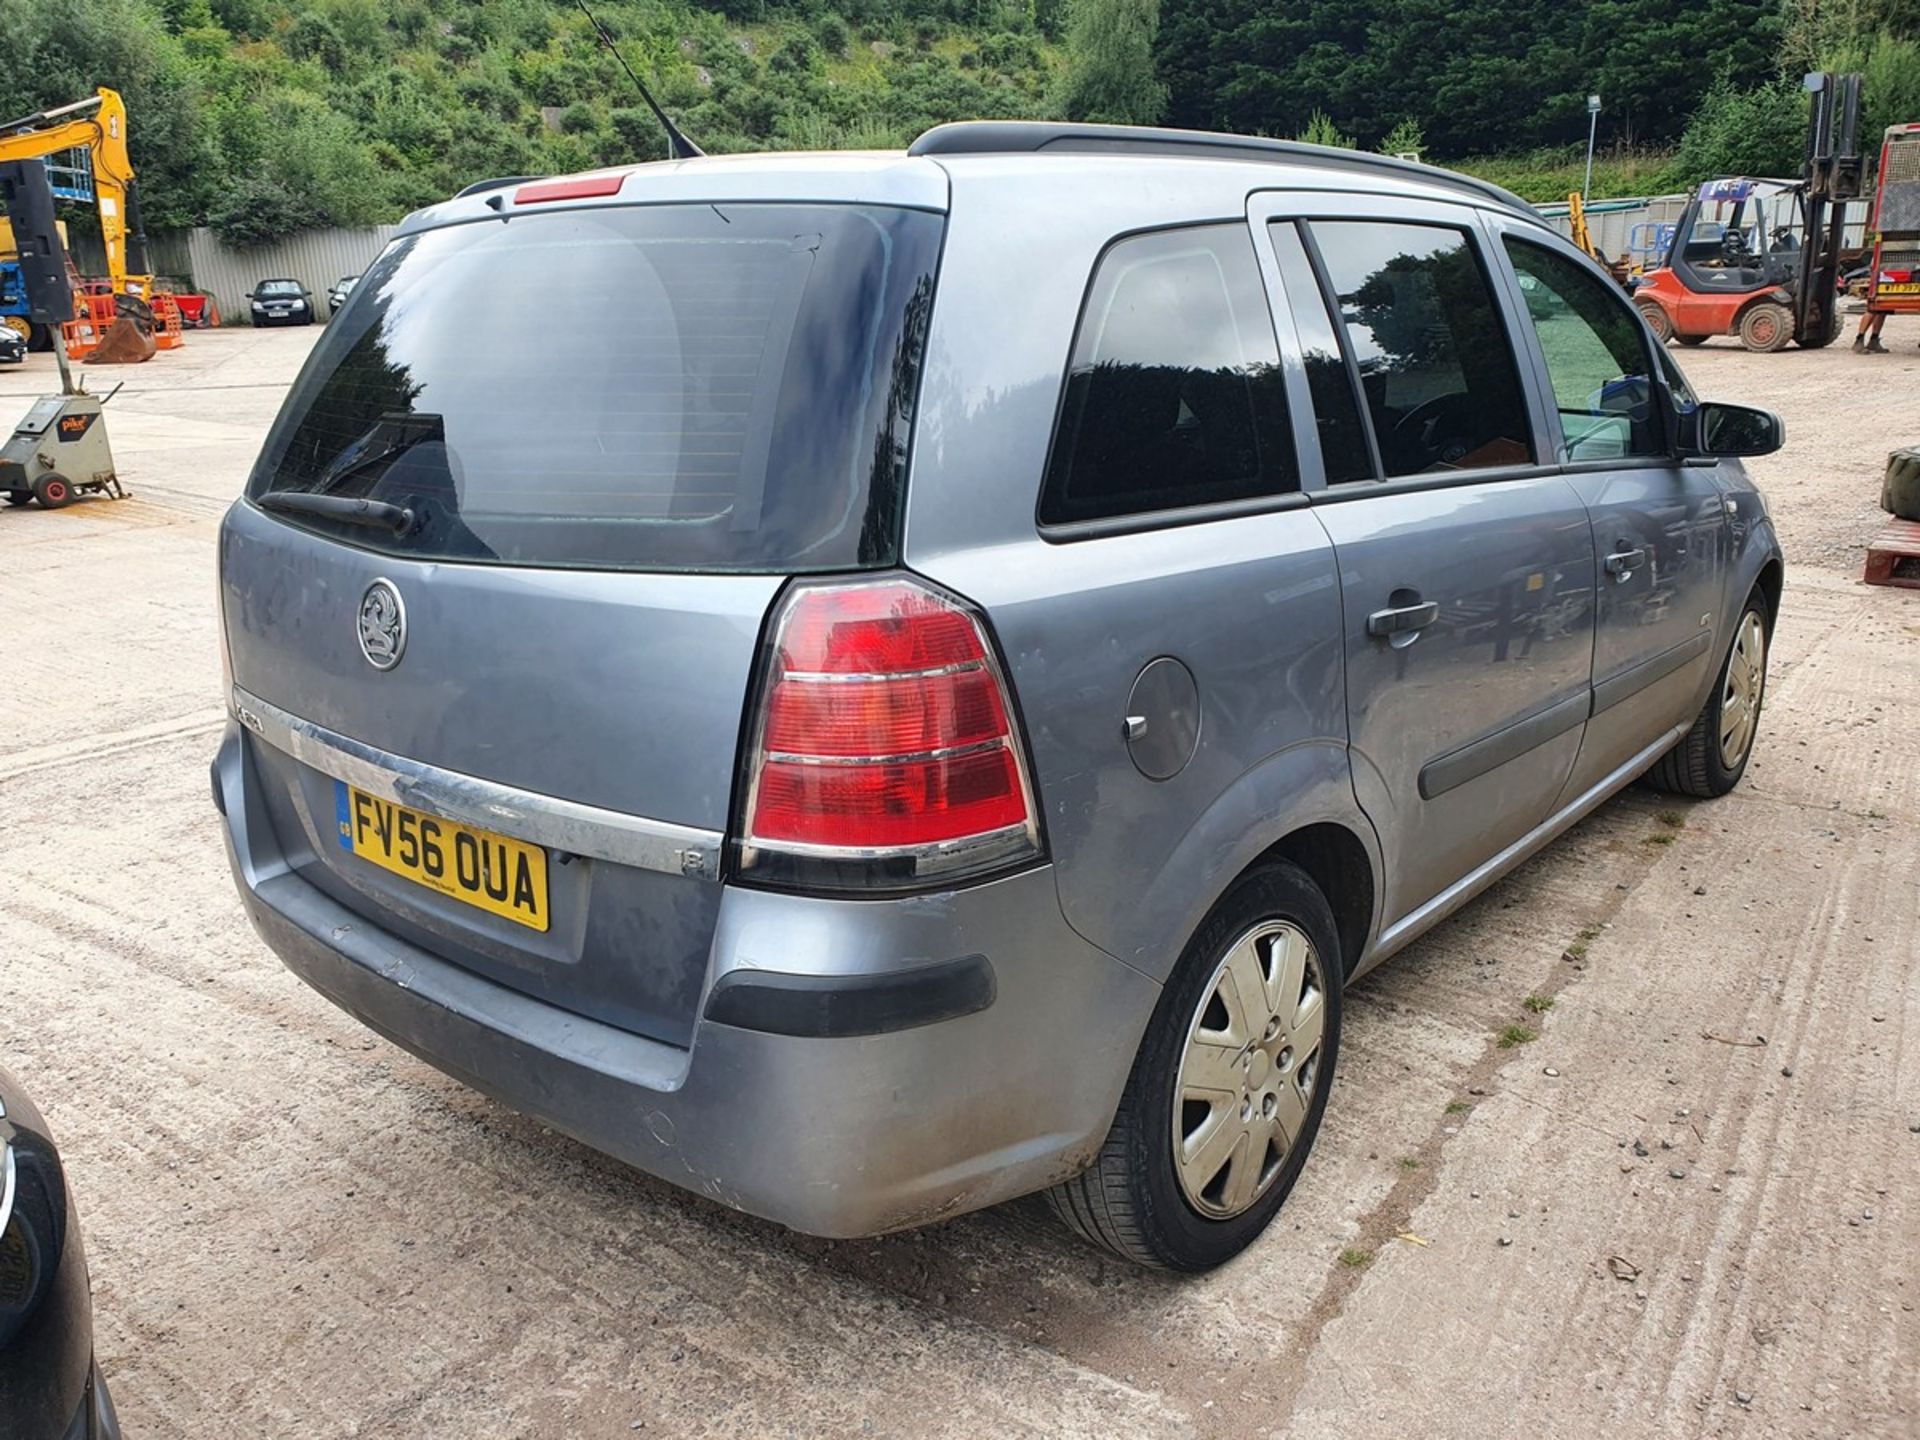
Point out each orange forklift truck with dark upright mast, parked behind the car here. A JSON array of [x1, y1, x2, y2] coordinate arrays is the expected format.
[[1634, 71, 1860, 349]]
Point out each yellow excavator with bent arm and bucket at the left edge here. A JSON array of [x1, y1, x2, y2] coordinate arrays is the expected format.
[[0, 86, 154, 353]]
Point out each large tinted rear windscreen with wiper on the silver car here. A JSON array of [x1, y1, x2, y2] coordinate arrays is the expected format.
[[248, 204, 943, 570]]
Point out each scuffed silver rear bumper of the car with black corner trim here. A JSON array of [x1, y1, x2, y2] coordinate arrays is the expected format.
[[213, 724, 1158, 1236]]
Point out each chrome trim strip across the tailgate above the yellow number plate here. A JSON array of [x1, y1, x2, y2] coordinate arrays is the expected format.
[[230, 685, 726, 879]]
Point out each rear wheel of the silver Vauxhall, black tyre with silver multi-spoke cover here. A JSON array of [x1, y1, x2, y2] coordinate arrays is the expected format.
[[1046, 860, 1344, 1271]]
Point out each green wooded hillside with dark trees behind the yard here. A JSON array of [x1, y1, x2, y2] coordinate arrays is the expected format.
[[0, 0, 1920, 242]]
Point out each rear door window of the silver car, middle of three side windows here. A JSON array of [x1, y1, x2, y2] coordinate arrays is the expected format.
[[1313, 221, 1534, 474]]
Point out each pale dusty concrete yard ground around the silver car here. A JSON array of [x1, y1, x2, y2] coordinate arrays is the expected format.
[[0, 319, 1920, 1438]]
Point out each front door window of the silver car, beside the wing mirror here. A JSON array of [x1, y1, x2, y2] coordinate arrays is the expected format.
[[1507, 238, 1665, 461]]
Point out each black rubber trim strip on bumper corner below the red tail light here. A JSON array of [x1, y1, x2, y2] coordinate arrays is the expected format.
[[707, 954, 995, 1041]]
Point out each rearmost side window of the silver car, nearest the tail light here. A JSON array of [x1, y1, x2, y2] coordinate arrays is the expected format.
[[1041, 225, 1300, 524]]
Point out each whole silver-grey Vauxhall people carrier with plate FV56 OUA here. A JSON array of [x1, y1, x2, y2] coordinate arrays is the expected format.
[[213, 123, 1782, 1269]]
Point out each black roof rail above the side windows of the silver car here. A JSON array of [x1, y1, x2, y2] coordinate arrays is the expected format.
[[906, 121, 1538, 219]]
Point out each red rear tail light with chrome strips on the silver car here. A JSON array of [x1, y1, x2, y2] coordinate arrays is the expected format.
[[739, 578, 1041, 889]]
